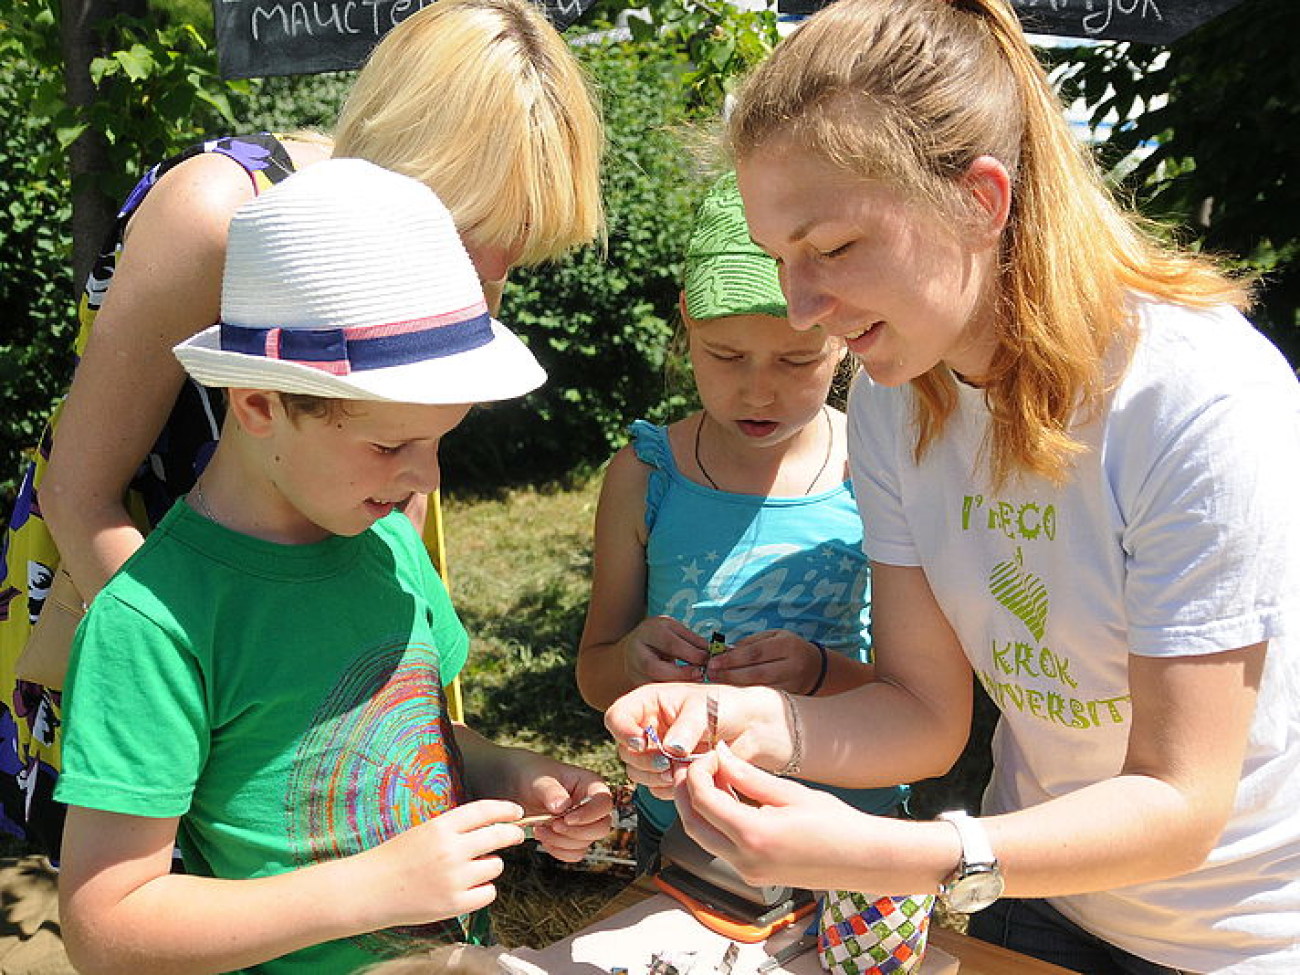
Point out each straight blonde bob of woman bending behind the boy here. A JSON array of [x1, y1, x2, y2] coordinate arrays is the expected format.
[[334, 0, 605, 264]]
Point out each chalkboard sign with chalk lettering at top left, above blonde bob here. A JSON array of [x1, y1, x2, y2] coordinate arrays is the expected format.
[[213, 0, 593, 78]]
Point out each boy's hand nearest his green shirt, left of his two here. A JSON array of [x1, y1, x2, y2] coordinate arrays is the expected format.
[[359, 800, 524, 927]]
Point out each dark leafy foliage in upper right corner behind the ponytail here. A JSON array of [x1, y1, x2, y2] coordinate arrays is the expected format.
[[1058, 0, 1300, 351]]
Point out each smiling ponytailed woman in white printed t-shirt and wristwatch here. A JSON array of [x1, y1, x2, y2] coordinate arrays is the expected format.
[[606, 0, 1300, 975]]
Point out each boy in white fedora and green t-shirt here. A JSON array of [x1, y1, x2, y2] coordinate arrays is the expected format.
[[57, 160, 612, 975]]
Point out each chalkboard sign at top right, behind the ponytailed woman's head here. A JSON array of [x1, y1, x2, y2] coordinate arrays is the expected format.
[[776, 0, 1242, 44]]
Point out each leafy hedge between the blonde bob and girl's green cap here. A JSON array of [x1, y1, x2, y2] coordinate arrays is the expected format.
[[443, 43, 705, 488]]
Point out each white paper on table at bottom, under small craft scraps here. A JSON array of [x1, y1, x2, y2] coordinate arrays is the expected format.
[[502, 894, 958, 975]]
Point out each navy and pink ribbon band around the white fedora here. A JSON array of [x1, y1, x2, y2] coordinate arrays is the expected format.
[[221, 302, 493, 376]]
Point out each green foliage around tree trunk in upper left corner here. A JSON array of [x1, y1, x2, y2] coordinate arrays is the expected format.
[[0, 0, 250, 511]]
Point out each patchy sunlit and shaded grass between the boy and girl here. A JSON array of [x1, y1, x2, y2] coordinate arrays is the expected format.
[[443, 478, 995, 948]]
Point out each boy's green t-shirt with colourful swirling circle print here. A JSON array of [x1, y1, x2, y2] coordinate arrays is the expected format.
[[57, 503, 480, 975]]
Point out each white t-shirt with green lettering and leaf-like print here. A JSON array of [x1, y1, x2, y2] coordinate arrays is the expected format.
[[849, 302, 1300, 975]]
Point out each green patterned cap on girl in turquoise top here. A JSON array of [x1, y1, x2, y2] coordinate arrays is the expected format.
[[684, 173, 787, 319]]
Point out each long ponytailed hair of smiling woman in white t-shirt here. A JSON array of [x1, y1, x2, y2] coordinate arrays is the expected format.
[[728, 0, 1248, 485]]
